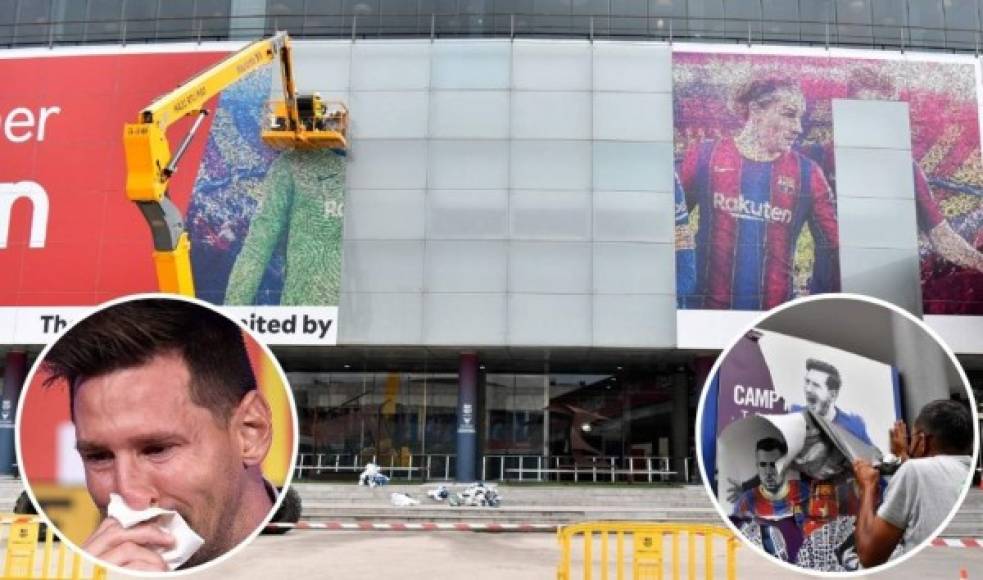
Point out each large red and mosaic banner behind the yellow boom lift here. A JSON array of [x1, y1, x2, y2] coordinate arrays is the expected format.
[[0, 45, 345, 344]]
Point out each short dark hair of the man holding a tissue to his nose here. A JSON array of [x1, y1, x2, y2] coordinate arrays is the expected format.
[[42, 298, 256, 422]]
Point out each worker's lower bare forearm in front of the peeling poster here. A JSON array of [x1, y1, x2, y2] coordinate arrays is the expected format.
[[853, 459, 904, 568]]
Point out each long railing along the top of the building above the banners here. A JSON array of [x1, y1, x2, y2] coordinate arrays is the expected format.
[[0, 12, 983, 54]]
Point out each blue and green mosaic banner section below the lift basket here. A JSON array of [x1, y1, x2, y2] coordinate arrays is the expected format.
[[188, 66, 345, 312]]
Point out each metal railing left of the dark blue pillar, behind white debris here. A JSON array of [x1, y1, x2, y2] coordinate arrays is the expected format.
[[294, 453, 455, 481]]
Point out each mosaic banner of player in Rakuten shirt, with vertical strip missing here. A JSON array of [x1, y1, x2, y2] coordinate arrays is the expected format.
[[673, 51, 983, 314]]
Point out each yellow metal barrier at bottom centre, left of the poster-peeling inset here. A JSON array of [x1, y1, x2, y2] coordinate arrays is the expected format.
[[556, 522, 739, 580]]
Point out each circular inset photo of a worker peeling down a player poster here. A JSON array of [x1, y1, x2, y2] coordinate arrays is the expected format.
[[697, 295, 979, 576]]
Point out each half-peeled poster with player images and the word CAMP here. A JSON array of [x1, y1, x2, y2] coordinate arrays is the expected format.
[[703, 330, 901, 571]]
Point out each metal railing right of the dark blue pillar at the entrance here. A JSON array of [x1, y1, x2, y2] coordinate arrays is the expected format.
[[481, 455, 690, 483]]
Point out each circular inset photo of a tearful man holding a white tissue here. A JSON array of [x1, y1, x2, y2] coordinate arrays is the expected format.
[[16, 295, 297, 573]]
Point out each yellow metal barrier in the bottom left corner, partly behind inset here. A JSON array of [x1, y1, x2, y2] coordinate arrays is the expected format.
[[0, 514, 106, 580]]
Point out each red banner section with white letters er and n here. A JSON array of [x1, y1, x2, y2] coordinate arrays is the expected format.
[[0, 51, 224, 306]]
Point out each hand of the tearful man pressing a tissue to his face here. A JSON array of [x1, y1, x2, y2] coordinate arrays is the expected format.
[[82, 518, 174, 572]]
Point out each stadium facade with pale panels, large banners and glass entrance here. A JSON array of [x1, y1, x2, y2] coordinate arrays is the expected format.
[[0, 0, 983, 481]]
